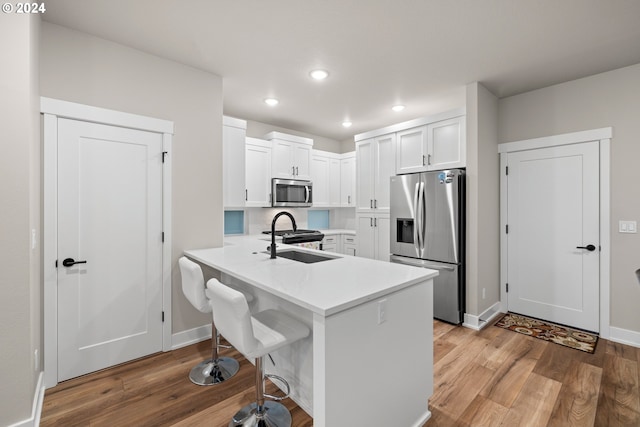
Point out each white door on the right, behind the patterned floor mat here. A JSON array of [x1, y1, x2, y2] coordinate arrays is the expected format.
[[507, 141, 600, 331]]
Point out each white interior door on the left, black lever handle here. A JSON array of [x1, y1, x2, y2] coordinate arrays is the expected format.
[[57, 119, 162, 381]]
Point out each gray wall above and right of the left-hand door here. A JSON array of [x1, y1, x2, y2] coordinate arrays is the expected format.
[[40, 23, 223, 333]]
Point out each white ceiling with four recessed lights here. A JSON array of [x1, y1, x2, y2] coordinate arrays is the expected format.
[[43, 0, 640, 141]]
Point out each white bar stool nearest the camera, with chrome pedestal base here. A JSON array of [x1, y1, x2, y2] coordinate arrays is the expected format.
[[206, 279, 309, 427]]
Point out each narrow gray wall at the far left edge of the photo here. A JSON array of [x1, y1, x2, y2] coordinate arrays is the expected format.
[[0, 14, 42, 425]]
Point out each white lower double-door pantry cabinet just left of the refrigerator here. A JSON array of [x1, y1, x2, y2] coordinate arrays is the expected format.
[[356, 214, 391, 261]]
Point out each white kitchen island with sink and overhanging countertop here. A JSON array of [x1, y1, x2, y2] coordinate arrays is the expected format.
[[185, 236, 438, 427]]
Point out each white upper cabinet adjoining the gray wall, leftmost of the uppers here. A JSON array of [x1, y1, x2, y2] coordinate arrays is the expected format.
[[222, 116, 247, 208]]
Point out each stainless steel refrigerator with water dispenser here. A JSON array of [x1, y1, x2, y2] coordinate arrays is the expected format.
[[391, 169, 466, 324]]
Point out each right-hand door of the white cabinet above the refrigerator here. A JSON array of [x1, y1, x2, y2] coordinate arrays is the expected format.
[[427, 117, 467, 170]]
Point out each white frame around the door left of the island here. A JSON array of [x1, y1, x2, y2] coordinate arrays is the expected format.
[[40, 97, 173, 388]]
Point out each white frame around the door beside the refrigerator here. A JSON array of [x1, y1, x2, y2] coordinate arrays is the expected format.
[[498, 127, 613, 339]]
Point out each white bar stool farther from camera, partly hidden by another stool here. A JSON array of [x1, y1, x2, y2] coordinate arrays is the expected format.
[[178, 257, 240, 385]]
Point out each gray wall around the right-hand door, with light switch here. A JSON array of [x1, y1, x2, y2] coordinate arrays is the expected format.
[[498, 64, 640, 333]]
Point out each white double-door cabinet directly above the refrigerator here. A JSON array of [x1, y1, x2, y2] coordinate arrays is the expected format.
[[396, 116, 466, 174]]
